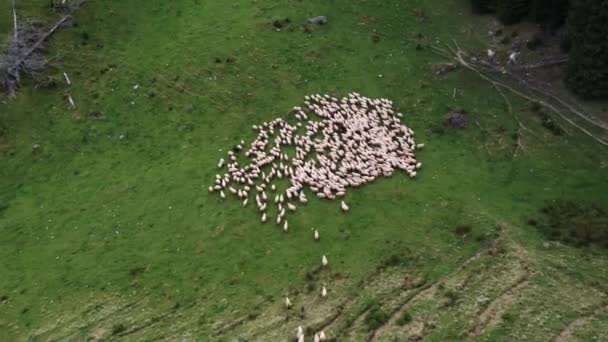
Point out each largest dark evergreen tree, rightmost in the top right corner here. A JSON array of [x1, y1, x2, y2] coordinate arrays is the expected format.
[[566, 0, 608, 99]]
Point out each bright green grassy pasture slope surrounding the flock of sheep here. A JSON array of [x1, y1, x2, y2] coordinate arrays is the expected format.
[[0, 0, 608, 341]]
